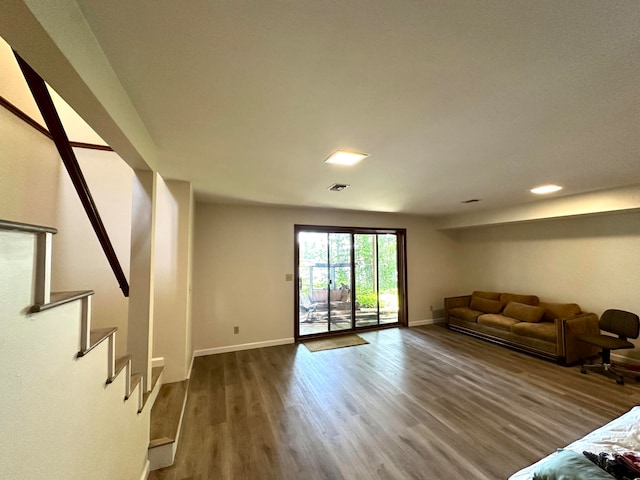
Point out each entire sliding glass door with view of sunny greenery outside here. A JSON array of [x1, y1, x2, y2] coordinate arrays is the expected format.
[[295, 225, 407, 340]]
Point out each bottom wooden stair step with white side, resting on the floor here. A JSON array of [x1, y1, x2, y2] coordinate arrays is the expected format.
[[149, 379, 189, 449]]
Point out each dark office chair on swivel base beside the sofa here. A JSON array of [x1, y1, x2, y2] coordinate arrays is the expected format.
[[576, 309, 640, 385]]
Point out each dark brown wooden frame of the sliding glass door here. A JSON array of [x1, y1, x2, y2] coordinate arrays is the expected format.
[[293, 224, 409, 341]]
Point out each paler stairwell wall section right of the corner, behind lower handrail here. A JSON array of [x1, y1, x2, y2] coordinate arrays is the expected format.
[[52, 148, 133, 355]]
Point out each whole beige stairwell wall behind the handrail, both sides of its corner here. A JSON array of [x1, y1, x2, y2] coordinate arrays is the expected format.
[[0, 39, 132, 353]]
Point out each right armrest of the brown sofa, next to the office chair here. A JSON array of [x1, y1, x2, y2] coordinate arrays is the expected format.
[[555, 313, 600, 364]]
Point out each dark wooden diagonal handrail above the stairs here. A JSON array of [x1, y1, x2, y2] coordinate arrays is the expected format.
[[13, 51, 129, 297]]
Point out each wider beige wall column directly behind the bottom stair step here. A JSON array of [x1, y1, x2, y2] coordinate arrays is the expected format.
[[153, 177, 193, 382]]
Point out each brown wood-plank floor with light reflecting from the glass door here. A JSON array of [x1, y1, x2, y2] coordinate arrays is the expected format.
[[149, 326, 640, 480]]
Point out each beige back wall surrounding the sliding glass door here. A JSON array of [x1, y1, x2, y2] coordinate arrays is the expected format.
[[193, 203, 456, 350]]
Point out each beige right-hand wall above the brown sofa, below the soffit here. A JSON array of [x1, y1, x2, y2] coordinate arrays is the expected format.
[[451, 211, 640, 354]]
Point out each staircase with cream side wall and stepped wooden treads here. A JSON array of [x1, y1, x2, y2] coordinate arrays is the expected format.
[[0, 220, 162, 480]]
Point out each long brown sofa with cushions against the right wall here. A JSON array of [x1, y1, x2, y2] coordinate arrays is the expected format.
[[444, 291, 600, 365]]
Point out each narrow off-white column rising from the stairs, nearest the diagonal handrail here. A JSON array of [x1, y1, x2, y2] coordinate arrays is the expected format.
[[127, 170, 157, 391]]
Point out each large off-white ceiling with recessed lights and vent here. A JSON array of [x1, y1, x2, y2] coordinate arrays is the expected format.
[[12, 0, 640, 215]]
